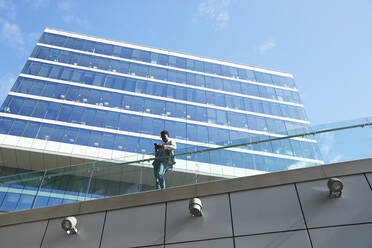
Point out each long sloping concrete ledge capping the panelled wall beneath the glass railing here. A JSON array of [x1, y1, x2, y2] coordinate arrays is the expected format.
[[0, 159, 372, 226]]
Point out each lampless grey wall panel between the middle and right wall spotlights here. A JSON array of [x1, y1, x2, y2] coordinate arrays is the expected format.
[[231, 184, 305, 235]]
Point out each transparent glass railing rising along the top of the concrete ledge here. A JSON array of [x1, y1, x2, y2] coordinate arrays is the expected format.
[[0, 118, 372, 211]]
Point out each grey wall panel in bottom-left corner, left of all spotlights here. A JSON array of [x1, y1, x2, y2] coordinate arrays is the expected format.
[[0, 221, 48, 248]]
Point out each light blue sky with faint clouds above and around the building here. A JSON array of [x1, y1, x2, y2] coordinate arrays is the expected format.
[[0, 0, 372, 124]]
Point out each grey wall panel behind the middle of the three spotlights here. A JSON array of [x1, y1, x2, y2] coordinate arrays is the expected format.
[[165, 194, 232, 243]]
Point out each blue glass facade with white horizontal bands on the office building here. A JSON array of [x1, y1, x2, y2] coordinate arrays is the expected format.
[[0, 29, 322, 211]]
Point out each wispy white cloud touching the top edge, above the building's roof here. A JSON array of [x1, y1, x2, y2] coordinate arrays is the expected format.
[[194, 0, 230, 29]]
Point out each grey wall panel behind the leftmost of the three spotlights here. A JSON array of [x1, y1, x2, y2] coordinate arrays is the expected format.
[[42, 212, 105, 248]]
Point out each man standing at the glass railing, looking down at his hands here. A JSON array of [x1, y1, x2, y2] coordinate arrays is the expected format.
[[152, 130, 176, 189]]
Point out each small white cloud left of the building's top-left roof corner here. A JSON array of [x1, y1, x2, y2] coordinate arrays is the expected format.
[[0, 20, 25, 49]]
